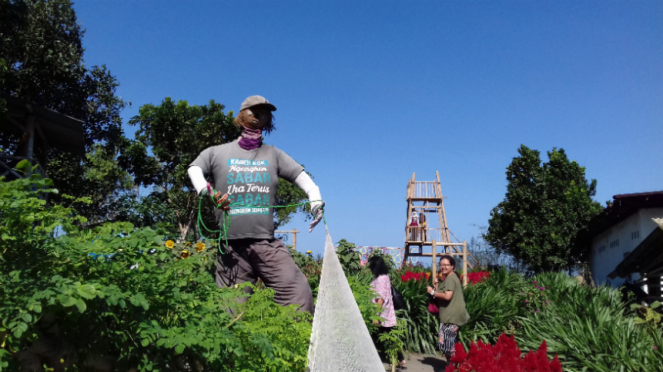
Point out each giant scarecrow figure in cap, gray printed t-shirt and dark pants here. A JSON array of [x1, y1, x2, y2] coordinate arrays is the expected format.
[[188, 96, 324, 314]]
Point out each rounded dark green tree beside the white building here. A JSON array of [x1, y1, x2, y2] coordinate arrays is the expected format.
[[484, 145, 601, 272]]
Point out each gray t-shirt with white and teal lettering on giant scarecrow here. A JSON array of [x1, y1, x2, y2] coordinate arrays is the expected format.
[[190, 140, 304, 239]]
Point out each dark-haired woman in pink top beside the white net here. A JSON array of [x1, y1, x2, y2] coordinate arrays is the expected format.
[[368, 256, 405, 367]]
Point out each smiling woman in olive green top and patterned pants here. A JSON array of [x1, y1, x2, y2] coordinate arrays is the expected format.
[[427, 255, 470, 362]]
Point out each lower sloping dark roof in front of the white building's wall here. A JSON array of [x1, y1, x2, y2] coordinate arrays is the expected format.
[[608, 218, 663, 279]]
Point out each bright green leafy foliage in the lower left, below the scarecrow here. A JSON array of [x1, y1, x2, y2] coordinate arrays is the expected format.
[[0, 171, 311, 371]]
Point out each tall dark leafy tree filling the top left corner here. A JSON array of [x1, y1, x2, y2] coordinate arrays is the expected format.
[[0, 0, 129, 221]]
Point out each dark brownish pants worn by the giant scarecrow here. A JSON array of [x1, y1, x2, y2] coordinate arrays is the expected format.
[[215, 239, 315, 314]]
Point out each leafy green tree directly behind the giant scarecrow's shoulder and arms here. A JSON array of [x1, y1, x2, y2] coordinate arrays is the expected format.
[[120, 98, 306, 238]]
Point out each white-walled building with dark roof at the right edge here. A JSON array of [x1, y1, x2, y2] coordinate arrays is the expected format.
[[590, 191, 663, 300]]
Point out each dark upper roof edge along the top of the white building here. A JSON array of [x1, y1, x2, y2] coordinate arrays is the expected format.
[[590, 191, 663, 237]]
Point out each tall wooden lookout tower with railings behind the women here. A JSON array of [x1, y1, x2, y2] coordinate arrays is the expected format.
[[403, 171, 473, 284]]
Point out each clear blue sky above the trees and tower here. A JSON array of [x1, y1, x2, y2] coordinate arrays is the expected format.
[[74, 0, 663, 253]]
